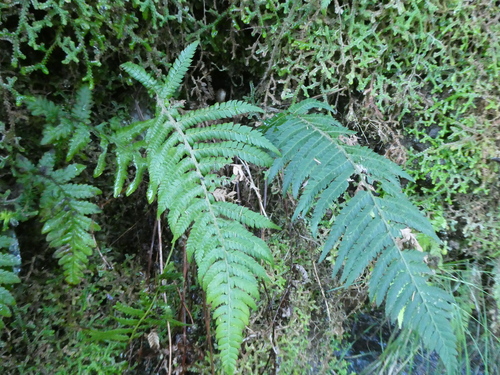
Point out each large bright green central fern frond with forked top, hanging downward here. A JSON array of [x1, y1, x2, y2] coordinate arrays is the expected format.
[[122, 43, 277, 374]]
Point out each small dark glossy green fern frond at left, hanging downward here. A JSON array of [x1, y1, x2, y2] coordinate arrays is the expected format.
[[18, 152, 101, 284]]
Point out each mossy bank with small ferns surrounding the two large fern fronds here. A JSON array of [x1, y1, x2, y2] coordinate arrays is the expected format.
[[0, 0, 500, 374]]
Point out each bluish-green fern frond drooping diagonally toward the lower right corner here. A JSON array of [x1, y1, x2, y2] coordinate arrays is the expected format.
[[266, 100, 457, 373]]
